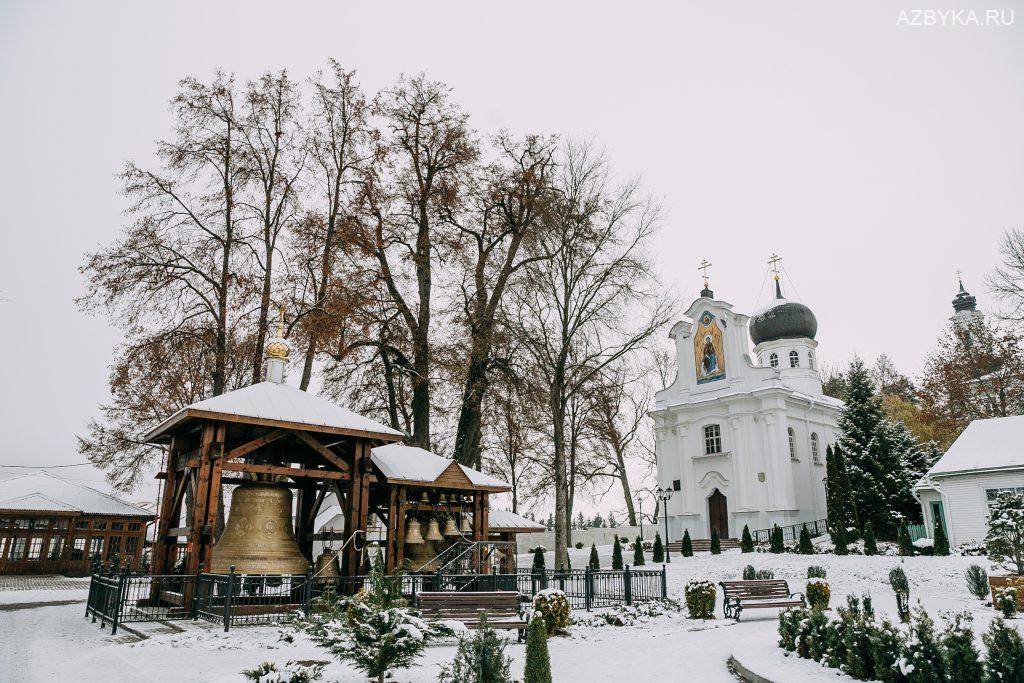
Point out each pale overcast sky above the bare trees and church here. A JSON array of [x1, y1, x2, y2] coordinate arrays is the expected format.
[[0, 0, 1024, 507]]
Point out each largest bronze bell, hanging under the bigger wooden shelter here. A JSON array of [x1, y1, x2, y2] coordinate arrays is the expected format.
[[210, 481, 309, 574]]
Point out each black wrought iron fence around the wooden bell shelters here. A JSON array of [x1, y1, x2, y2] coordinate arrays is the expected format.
[[85, 566, 668, 635]]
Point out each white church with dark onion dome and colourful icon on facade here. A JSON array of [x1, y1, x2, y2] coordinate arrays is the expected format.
[[651, 273, 843, 542]]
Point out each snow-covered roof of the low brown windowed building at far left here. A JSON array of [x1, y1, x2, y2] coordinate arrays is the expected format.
[[0, 472, 153, 517]]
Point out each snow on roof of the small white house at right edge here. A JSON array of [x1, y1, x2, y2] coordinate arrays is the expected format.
[[928, 416, 1024, 476]]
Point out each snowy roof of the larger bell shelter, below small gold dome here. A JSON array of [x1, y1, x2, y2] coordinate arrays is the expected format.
[[143, 382, 402, 441]]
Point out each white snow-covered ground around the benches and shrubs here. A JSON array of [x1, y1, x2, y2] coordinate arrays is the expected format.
[[0, 547, 1024, 683]]
